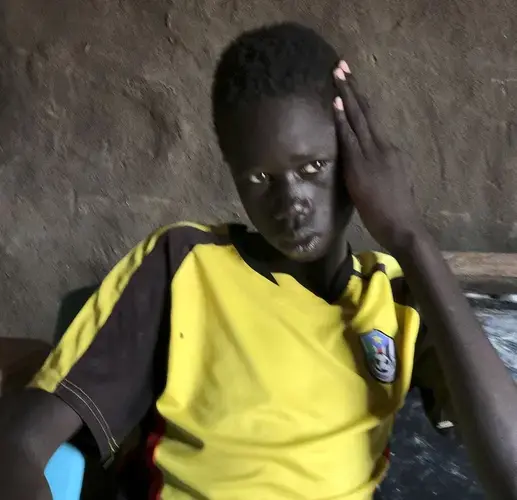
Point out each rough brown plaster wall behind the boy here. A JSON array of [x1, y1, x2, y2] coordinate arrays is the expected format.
[[0, 0, 517, 339]]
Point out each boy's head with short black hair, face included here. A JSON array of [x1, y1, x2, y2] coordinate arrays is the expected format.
[[212, 23, 352, 262]]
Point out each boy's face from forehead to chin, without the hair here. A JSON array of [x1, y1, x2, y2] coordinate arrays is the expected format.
[[224, 98, 352, 262]]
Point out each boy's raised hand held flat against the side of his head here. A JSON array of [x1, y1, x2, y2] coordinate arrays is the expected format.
[[334, 61, 423, 252]]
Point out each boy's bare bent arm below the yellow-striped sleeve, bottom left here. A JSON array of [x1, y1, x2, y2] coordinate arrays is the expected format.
[[0, 389, 82, 500]]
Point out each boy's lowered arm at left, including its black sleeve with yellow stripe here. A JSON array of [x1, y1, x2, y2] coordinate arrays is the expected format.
[[0, 230, 181, 500]]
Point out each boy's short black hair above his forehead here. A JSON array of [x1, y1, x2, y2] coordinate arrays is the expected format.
[[212, 22, 339, 146]]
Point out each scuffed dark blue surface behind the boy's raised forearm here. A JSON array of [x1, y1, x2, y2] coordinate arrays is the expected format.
[[382, 309, 517, 500]]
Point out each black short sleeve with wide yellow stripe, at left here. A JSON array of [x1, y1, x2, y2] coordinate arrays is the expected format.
[[30, 229, 172, 461]]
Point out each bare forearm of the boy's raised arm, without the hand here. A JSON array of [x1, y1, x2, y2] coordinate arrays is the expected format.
[[393, 230, 517, 500]]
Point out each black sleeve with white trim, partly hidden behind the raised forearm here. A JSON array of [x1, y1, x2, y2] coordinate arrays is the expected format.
[[412, 323, 455, 433]]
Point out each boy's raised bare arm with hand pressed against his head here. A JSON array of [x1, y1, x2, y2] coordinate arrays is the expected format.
[[334, 61, 517, 500]]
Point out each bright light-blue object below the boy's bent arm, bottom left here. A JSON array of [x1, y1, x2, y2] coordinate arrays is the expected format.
[[45, 443, 85, 500]]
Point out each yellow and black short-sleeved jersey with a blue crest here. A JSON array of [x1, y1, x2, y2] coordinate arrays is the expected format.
[[31, 224, 445, 500]]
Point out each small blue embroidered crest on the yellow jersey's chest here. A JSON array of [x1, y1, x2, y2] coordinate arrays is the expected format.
[[360, 330, 397, 384]]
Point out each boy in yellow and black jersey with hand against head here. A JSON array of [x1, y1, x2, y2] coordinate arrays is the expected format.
[[0, 24, 517, 500]]
